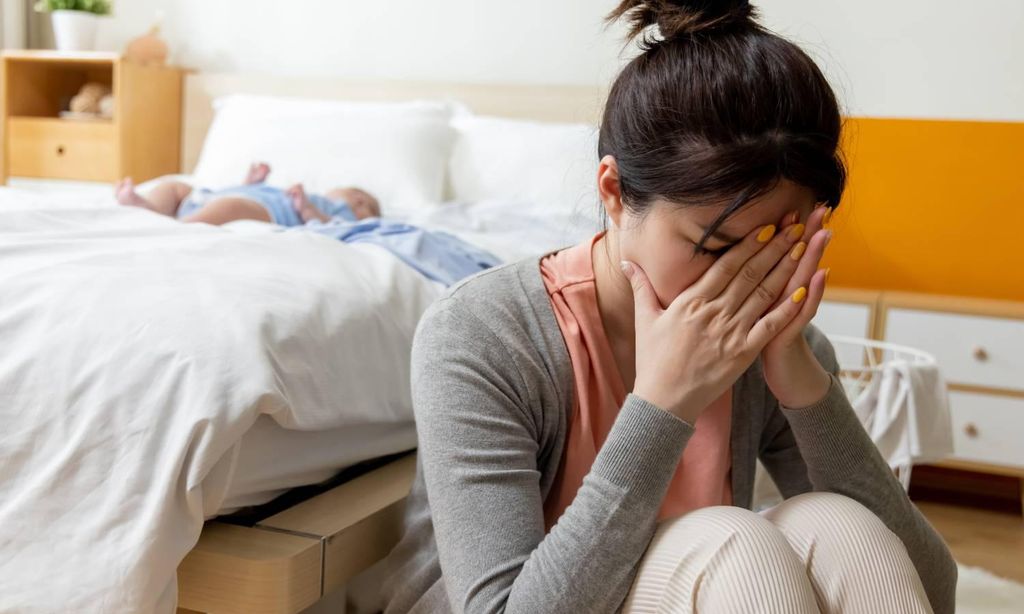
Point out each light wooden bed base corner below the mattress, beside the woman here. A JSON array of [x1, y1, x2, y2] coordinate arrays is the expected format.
[[178, 453, 416, 614]]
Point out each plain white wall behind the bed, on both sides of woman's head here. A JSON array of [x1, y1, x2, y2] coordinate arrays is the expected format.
[[88, 0, 1024, 121]]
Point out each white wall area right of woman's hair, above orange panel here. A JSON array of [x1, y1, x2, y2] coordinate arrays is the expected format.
[[755, 0, 1024, 121]]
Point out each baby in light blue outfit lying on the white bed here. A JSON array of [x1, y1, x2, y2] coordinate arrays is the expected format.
[[115, 163, 381, 226]]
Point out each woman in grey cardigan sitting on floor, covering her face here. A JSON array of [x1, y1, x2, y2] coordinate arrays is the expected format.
[[384, 0, 956, 614]]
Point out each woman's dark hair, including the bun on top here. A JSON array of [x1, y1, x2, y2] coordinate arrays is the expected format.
[[598, 0, 846, 244]]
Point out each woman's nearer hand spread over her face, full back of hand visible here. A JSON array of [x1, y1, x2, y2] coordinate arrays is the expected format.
[[623, 217, 820, 424]]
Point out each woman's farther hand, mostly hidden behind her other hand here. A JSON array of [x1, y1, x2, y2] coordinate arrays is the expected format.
[[762, 207, 831, 407]]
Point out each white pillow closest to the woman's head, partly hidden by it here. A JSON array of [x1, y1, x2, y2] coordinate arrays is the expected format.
[[449, 116, 599, 218]]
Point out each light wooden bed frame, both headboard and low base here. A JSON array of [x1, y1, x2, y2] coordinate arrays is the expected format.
[[178, 74, 604, 614]]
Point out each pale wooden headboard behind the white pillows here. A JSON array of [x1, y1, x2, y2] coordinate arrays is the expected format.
[[181, 73, 605, 173]]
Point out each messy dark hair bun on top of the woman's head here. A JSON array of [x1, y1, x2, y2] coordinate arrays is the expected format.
[[607, 0, 755, 47]]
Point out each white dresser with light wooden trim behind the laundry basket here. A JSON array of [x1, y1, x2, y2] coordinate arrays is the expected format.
[[814, 289, 1024, 513]]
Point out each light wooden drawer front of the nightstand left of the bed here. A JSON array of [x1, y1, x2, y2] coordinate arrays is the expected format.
[[7, 118, 118, 181]]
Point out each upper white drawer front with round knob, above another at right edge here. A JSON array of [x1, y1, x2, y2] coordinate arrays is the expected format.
[[886, 309, 1024, 390]]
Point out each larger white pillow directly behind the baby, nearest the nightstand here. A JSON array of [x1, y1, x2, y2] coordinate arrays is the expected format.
[[195, 95, 454, 212]]
